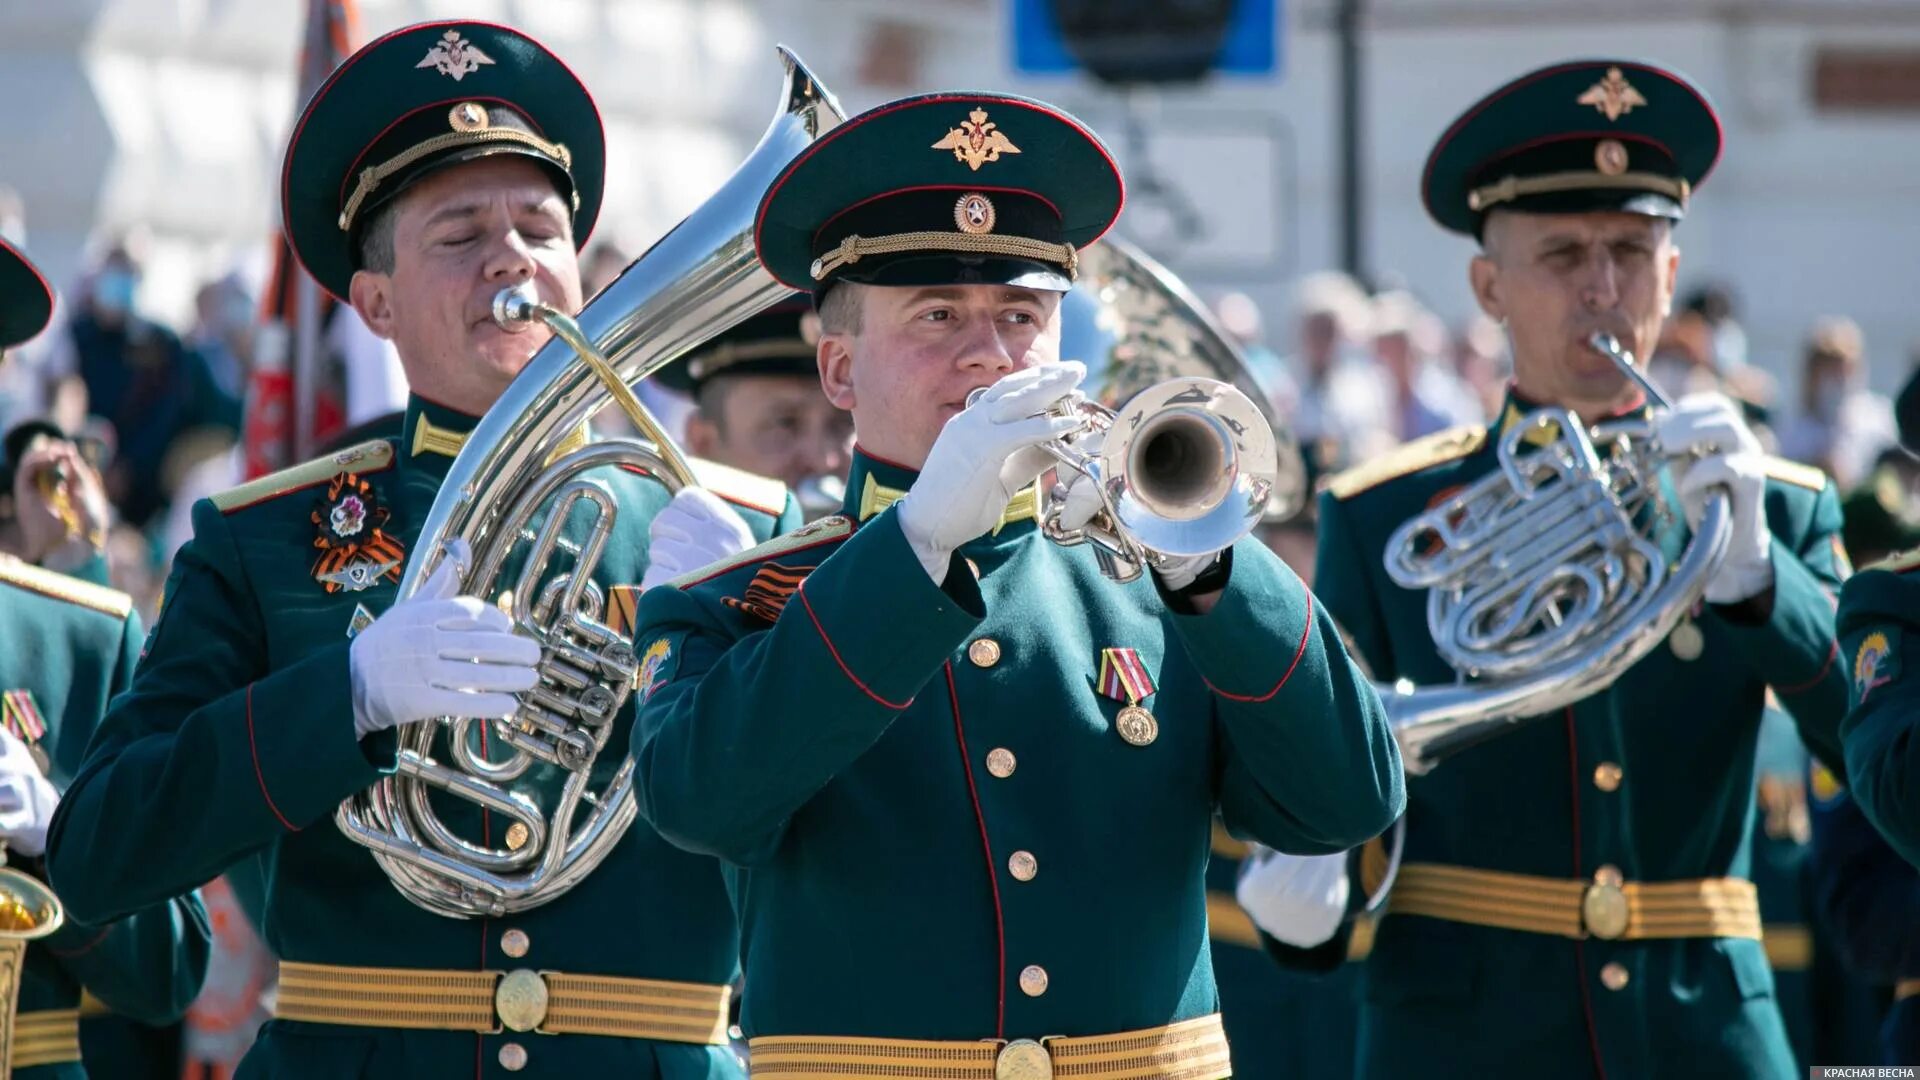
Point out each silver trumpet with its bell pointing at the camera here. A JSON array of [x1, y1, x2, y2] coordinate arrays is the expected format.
[[968, 375, 1279, 582]]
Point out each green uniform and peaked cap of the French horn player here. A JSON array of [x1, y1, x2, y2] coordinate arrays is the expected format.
[[1315, 61, 1845, 1078]]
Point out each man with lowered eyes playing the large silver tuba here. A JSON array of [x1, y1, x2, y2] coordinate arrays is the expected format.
[[52, 21, 797, 1078]]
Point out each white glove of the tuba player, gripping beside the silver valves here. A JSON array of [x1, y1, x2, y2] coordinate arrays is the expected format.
[[348, 540, 540, 738]]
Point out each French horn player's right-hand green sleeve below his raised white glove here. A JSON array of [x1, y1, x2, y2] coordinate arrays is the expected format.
[[1715, 482, 1847, 771]]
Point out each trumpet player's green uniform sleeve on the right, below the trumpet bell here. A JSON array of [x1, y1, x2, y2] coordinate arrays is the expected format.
[[1169, 538, 1407, 855]]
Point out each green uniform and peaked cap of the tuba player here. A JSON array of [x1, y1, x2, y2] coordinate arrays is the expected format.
[[50, 23, 797, 1078]]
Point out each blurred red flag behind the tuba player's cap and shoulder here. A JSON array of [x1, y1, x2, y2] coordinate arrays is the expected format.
[[242, 0, 359, 479]]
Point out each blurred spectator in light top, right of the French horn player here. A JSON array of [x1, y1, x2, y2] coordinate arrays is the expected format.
[[1780, 317, 1897, 490]]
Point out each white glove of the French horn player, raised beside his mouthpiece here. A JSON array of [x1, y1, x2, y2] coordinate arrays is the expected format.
[[1655, 394, 1774, 603]]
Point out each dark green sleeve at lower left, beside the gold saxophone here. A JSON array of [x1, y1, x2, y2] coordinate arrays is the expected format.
[[44, 880, 213, 1024]]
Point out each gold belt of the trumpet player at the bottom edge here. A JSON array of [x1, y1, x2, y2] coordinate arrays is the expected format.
[[747, 1015, 1233, 1080]]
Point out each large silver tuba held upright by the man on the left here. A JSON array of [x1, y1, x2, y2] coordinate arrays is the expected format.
[[334, 48, 843, 919]]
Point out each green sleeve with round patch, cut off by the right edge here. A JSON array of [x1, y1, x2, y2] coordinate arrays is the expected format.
[[1839, 571, 1920, 865]]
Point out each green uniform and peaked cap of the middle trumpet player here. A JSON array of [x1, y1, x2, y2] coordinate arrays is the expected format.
[[636, 94, 1400, 1080]]
